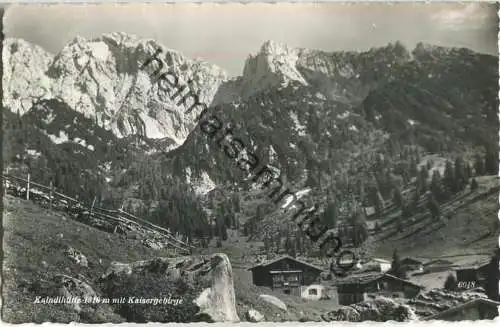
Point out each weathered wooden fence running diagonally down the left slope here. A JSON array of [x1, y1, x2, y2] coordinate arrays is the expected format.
[[2, 174, 192, 254]]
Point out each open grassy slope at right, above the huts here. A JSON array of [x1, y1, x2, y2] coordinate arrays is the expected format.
[[373, 176, 498, 263]]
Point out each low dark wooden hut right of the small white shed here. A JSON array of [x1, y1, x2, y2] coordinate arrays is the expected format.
[[335, 273, 423, 305]]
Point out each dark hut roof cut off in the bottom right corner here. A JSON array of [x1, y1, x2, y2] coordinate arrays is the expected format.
[[425, 298, 500, 321]]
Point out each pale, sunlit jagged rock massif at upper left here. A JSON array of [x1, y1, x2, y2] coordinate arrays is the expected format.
[[4, 33, 227, 147]]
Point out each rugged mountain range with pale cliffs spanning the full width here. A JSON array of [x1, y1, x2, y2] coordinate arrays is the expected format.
[[3, 33, 498, 241]]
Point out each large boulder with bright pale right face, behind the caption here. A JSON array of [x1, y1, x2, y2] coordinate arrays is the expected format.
[[100, 254, 239, 323]]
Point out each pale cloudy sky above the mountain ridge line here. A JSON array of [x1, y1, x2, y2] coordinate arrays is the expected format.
[[4, 3, 499, 76]]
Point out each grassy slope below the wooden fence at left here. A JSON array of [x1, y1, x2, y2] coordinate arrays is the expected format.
[[2, 196, 176, 323]]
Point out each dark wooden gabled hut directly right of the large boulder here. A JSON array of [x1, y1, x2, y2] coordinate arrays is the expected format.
[[249, 256, 323, 296]]
